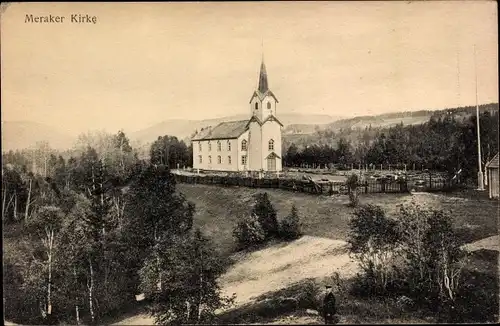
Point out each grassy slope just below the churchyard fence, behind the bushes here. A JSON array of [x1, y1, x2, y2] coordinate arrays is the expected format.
[[177, 184, 498, 253]]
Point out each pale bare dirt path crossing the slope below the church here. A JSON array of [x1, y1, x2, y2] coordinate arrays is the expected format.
[[114, 236, 358, 325]]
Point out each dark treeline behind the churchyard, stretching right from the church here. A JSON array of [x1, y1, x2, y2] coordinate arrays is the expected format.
[[283, 110, 499, 180]]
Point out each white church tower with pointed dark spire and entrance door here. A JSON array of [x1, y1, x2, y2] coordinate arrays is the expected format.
[[248, 58, 283, 171]]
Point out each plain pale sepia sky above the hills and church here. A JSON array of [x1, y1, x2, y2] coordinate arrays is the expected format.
[[0, 1, 498, 134]]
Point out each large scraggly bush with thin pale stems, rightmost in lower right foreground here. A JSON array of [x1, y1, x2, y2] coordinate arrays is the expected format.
[[399, 203, 466, 311]]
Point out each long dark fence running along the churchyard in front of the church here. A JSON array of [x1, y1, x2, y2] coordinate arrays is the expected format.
[[171, 174, 418, 195]]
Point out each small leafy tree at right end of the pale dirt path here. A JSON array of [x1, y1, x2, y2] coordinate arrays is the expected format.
[[347, 204, 399, 293]]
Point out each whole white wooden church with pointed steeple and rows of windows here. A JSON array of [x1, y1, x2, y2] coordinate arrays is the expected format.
[[191, 60, 283, 171]]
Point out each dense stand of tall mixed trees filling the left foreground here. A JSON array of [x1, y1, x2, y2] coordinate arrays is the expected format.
[[2, 132, 225, 324]]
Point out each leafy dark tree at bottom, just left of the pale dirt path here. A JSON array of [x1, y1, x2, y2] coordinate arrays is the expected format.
[[140, 230, 232, 325]]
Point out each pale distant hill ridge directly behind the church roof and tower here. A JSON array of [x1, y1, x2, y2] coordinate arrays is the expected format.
[[129, 113, 339, 143]]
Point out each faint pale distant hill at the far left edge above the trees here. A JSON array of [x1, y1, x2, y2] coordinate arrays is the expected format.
[[2, 121, 74, 152]]
